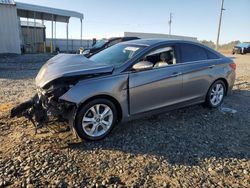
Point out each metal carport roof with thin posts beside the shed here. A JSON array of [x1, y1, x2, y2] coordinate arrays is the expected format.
[[16, 2, 84, 52]]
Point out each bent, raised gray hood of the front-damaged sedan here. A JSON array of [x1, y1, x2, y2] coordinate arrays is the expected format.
[[36, 54, 114, 88]]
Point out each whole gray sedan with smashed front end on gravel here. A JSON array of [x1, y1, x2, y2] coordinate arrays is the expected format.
[[11, 39, 236, 140]]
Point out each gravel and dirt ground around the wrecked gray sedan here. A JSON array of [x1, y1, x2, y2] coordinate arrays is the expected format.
[[0, 55, 250, 188]]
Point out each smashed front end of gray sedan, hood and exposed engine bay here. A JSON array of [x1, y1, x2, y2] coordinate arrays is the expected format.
[[10, 54, 113, 136]]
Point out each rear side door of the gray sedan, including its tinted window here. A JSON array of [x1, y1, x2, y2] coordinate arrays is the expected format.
[[179, 43, 219, 102]]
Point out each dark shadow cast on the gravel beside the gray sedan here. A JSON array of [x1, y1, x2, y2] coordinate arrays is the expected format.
[[70, 90, 250, 165]]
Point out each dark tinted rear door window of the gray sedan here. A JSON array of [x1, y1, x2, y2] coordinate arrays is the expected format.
[[180, 44, 208, 63]]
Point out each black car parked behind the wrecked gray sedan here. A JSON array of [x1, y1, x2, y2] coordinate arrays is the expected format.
[[83, 37, 140, 57]]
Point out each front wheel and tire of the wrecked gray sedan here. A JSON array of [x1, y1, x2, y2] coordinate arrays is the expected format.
[[75, 99, 117, 140]]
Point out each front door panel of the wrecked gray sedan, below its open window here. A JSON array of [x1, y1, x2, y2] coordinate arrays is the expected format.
[[129, 46, 182, 115]]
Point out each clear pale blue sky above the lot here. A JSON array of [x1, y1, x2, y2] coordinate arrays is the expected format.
[[17, 0, 250, 43]]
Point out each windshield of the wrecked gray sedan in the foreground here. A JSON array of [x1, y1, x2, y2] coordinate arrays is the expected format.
[[90, 44, 144, 66]]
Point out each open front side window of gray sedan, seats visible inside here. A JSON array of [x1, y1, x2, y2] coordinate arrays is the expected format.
[[140, 46, 176, 68]]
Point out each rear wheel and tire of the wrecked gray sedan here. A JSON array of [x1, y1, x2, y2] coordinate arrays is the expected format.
[[206, 80, 226, 108]]
